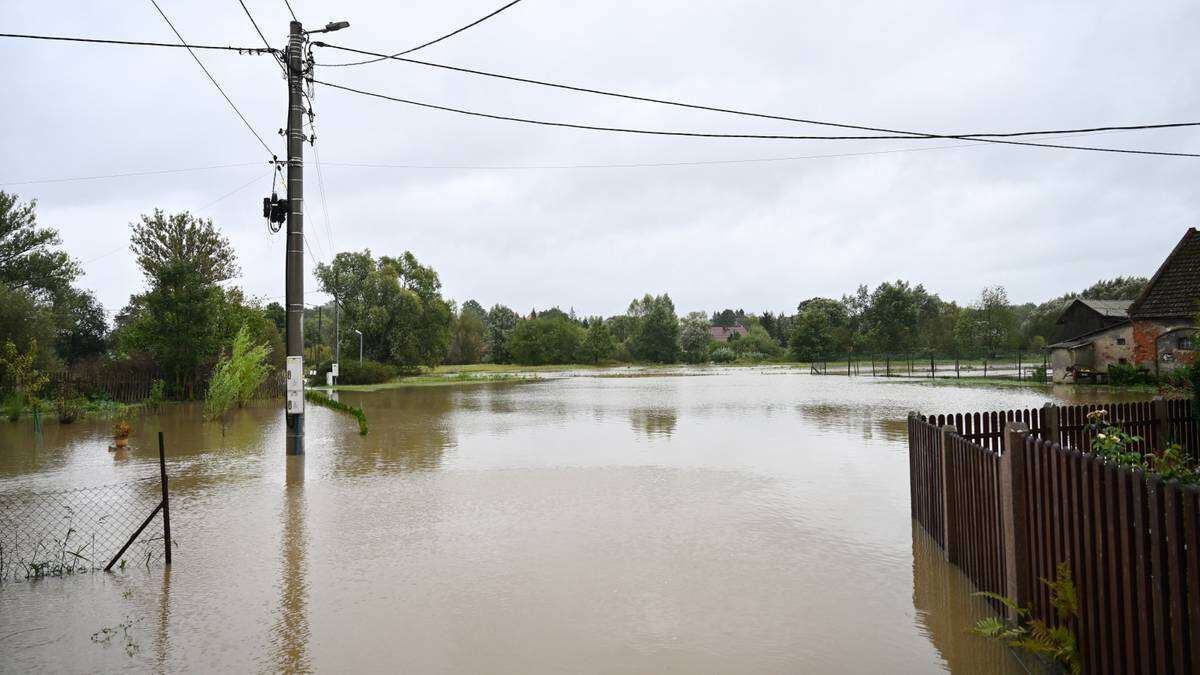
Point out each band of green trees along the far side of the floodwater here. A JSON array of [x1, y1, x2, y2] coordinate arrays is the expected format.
[[0, 192, 1161, 408]]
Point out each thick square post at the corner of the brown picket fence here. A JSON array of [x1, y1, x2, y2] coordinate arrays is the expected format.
[[1000, 422, 1031, 621]]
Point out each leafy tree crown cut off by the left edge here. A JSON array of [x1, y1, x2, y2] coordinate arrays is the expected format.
[[0, 191, 79, 301]]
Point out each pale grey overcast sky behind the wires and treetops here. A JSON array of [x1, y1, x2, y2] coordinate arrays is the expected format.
[[0, 0, 1200, 315]]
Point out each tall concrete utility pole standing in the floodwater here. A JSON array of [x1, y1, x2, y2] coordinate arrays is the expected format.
[[284, 22, 305, 455]]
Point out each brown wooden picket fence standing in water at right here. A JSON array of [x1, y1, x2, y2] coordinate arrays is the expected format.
[[908, 404, 1200, 675]]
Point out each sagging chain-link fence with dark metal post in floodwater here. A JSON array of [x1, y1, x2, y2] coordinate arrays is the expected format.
[[0, 476, 166, 583]]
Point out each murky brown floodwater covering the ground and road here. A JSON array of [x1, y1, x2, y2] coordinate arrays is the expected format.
[[0, 369, 1137, 673]]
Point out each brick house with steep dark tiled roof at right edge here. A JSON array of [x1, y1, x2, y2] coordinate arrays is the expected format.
[[1129, 227, 1200, 374]]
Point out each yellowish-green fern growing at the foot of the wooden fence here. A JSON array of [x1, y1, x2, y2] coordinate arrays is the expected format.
[[971, 562, 1084, 675]]
